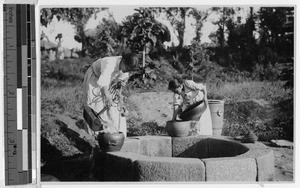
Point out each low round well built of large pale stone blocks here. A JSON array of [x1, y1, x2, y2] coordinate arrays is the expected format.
[[93, 136, 274, 182]]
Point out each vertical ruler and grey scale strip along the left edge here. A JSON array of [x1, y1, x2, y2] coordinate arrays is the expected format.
[[3, 4, 37, 185]]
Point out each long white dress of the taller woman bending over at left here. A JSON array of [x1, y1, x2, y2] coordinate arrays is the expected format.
[[83, 56, 129, 136]]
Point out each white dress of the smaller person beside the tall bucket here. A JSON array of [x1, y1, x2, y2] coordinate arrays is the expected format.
[[174, 80, 212, 135]]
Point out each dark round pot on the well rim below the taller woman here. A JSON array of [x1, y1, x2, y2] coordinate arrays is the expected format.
[[97, 132, 125, 152]]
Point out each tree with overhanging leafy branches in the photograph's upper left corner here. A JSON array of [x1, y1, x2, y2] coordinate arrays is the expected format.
[[40, 8, 107, 56]]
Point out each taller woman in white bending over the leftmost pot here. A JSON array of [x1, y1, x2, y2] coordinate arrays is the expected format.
[[83, 54, 139, 136]]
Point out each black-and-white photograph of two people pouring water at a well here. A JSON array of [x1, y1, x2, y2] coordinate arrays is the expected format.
[[36, 4, 296, 184]]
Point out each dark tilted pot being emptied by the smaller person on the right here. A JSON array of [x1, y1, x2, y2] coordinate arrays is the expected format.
[[179, 101, 207, 121]]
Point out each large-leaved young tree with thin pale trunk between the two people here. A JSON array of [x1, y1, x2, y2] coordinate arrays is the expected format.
[[121, 8, 170, 85]]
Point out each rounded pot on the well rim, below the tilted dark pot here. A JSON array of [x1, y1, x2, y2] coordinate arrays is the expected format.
[[166, 121, 191, 137]]
